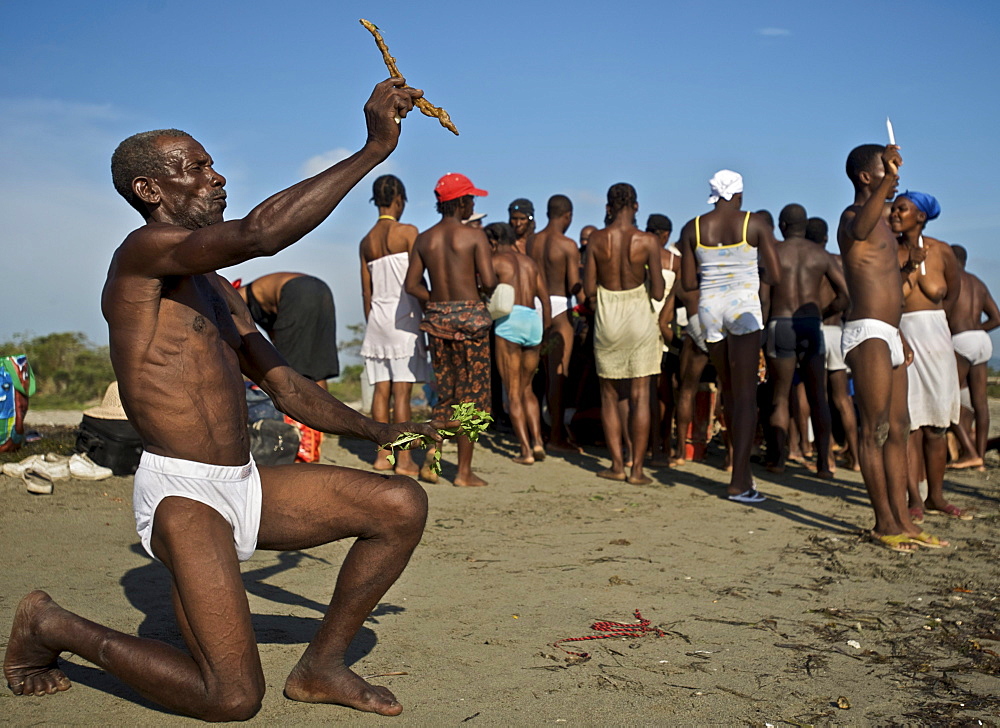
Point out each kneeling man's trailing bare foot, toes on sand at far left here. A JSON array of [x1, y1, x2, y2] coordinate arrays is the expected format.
[[3, 591, 72, 696]]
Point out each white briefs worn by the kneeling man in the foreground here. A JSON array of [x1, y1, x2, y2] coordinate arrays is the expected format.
[[132, 452, 262, 561]]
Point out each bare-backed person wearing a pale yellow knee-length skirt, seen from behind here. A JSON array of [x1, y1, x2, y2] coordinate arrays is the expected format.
[[583, 182, 663, 485]]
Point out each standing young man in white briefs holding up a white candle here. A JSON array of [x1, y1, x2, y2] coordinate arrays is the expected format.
[[837, 144, 946, 553]]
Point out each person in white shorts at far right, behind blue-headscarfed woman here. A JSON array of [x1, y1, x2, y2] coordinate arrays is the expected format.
[[948, 245, 1000, 471]]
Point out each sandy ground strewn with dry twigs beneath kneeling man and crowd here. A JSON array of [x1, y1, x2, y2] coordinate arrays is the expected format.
[[0, 412, 1000, 726]]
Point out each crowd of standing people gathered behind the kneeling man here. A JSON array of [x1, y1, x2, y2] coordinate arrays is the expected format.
[[361, 152, 1000, 551]]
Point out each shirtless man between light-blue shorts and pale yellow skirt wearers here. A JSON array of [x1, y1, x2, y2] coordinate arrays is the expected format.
[[528, 195, 583, 453]]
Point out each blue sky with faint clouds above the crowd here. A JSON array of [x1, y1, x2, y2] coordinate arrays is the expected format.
[[0, 0, 1000, 352]]
